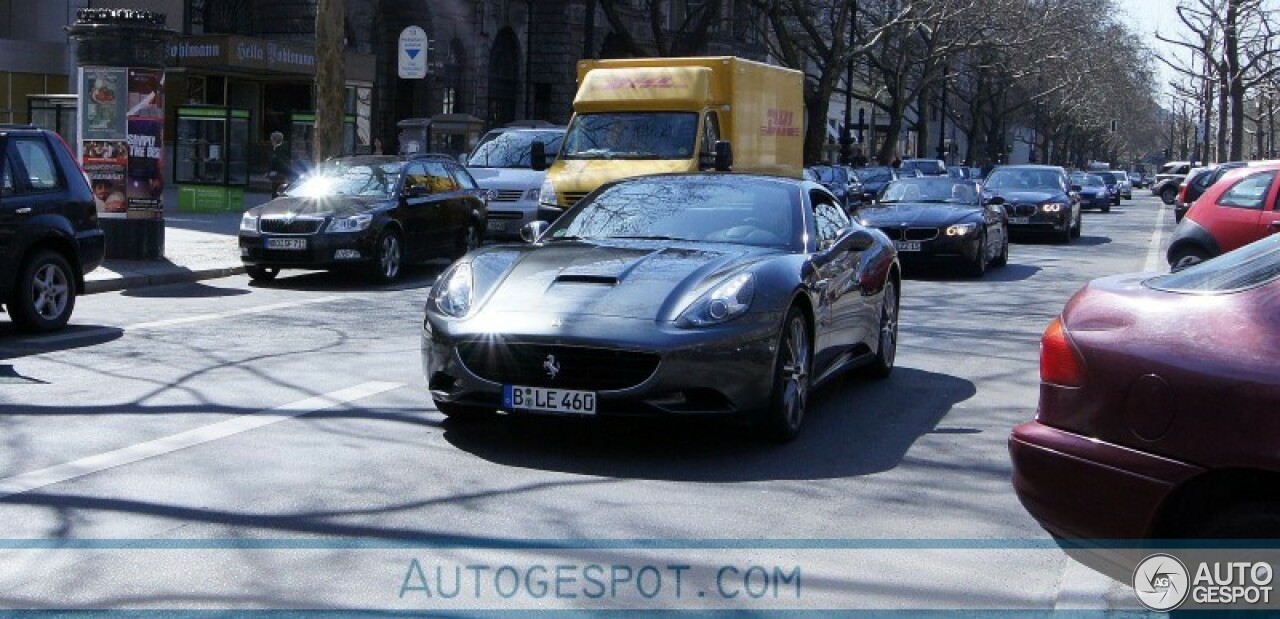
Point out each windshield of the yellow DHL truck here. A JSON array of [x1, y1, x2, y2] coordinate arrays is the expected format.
[[562, 111, 698, 159]]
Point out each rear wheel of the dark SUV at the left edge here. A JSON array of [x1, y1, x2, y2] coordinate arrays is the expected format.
[[9, 251, 76, 333]]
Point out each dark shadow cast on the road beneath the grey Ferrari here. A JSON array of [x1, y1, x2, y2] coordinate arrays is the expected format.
[[444, 367, 977, 482]]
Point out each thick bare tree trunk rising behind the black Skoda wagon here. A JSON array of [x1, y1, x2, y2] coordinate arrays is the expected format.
[[312, 0, 347, 162]]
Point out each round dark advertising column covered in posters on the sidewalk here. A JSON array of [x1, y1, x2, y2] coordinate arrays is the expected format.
[[69, 9, 173, 260]]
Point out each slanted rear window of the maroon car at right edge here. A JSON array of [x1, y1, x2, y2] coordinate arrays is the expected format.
[[1143, 234, 1280, 294]]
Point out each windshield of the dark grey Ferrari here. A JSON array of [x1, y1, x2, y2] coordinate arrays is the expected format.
[[545, 175, 803, 248]]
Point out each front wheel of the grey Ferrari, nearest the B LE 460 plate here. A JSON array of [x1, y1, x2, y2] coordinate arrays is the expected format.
[[762, 307, 813, 443]]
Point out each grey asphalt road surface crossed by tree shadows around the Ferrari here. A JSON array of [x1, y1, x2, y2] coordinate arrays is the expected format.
[[0, 195, 1172, 609]]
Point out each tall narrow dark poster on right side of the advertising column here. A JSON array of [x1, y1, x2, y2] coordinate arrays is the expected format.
[[125, 69, 164, 219]]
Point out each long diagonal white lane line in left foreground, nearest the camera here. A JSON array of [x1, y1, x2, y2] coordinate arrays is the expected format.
[[0, 381, 404, 499]]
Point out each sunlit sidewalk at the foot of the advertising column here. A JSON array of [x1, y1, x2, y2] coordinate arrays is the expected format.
[[84, 187, 271, 294]]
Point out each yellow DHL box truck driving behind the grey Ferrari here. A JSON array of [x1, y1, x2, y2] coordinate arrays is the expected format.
[[539, 56, 804, 212]]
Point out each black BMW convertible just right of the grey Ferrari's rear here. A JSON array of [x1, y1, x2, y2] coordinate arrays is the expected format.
[[858, 176, 1009, 278]]
